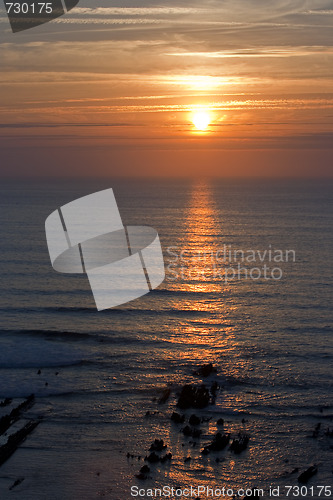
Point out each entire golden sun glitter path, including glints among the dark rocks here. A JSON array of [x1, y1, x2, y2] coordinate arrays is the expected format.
[[157, 182, 254, 499]]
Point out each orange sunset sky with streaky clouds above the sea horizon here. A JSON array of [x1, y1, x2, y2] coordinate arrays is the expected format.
[[0, 0, 333, 177]]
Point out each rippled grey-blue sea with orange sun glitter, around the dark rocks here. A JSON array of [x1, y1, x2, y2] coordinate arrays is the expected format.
[[0, 179, 333, 500]]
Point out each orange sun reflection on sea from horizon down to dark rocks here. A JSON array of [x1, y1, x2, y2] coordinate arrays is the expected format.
[[161, 181, 249, 378]]
